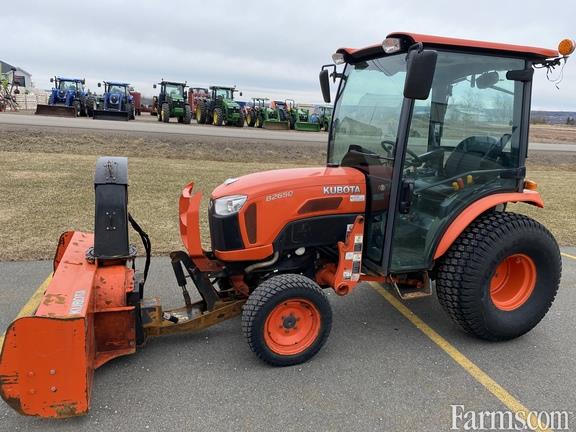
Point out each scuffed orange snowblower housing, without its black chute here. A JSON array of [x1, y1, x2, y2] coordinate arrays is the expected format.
[[0, 232, 136, 418]]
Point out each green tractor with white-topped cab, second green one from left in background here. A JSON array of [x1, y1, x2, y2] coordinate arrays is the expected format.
[[196, 86, 244, 127]]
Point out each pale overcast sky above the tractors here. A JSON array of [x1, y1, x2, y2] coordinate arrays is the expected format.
[[0, 0, 576, 111]]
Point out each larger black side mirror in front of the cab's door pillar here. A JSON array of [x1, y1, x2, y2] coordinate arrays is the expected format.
[[404, 49, 438, 100]]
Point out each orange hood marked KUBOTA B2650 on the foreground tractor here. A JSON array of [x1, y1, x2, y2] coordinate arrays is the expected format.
[[210, 167, 366, 261]]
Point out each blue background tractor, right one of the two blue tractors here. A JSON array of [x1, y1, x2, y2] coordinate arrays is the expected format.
[[93, 81, 136, 120]]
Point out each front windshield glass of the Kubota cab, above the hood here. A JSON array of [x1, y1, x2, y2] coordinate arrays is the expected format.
[[328, 54, 406, 165]]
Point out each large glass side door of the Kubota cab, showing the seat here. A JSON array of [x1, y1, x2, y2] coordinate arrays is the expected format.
[[390, 52, 525, 272]]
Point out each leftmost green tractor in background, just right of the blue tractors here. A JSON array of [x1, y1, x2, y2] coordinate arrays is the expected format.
[[152, 79, 192, 124]]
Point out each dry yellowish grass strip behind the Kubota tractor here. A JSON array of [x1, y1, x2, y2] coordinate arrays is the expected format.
[[0, 126, 576, 261]]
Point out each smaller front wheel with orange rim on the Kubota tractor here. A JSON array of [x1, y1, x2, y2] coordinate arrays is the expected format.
[[242, 274, 332, 366]]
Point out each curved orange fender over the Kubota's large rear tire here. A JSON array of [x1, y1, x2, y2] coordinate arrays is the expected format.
[[434, 189, 544, 260]]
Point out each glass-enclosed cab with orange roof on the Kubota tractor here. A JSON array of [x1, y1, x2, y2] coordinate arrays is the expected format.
[[321, 34, 568, 274]]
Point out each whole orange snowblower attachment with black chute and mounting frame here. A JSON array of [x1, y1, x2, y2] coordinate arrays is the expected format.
[[0, 157, 246, 418]]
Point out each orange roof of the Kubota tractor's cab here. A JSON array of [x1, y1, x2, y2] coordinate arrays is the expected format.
[[336, 32, 558, 61]]
